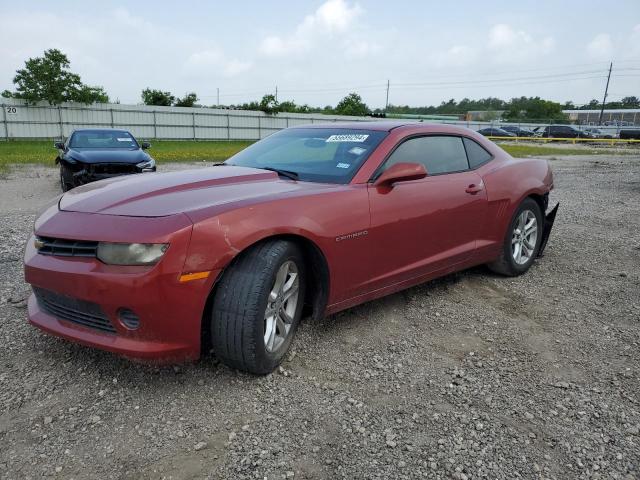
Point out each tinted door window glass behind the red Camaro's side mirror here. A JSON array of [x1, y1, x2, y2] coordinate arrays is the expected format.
[[385, 136, 469, 175]]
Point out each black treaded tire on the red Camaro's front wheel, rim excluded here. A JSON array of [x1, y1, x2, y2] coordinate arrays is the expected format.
[[210, 240, 306, 375]]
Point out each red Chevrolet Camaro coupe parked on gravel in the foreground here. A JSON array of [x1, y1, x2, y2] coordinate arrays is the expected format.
[[25, 122, 557, 374]]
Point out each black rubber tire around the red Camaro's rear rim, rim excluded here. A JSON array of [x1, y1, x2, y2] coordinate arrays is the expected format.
[[488, 198, 544, 277]]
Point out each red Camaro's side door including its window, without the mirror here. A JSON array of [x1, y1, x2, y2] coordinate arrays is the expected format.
[[368, 135, 491, 290]]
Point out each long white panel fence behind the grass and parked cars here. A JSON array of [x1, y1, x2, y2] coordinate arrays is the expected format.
[[0, 99, 632, 140]]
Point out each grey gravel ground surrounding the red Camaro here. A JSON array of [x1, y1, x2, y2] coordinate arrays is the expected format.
[[0, 155, 640, 480]]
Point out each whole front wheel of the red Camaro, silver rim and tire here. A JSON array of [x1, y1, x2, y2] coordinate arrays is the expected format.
[[211, 240, 305, 374]]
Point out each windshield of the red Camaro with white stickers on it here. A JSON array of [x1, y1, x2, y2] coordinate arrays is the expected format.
[[225, 128, 388, 183]]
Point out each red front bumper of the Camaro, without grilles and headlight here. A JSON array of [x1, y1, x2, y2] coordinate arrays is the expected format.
[[25, 212, 218, 363]]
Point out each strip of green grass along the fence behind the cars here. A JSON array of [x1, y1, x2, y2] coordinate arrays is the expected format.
[[0, 140, 638, 173]]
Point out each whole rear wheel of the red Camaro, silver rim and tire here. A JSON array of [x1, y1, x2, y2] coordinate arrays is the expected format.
[[489, 198, 543, 276]]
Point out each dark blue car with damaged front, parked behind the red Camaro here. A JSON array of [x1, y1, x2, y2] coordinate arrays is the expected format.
[[54, 129, 156, 192]]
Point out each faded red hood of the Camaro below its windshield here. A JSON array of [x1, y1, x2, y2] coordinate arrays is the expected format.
[[59, 166, 327, 217]]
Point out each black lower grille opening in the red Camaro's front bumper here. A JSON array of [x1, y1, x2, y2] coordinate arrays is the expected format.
[[33, 287, 116, 333]]
